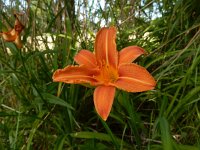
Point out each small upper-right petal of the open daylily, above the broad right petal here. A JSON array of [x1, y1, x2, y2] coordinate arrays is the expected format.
[[119, 46, 145, 64]]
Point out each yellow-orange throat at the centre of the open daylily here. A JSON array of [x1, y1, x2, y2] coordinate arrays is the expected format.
[[96, 64, 118, 84]]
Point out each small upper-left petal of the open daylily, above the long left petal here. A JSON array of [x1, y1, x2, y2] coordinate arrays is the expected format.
[[74, 50, 97, 68]]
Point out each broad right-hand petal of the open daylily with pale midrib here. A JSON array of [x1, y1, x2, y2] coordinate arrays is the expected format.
[[115, 64, 156, 92]]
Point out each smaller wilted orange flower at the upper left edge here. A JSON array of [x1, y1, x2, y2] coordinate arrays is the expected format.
[[0, 14, 24, 48]]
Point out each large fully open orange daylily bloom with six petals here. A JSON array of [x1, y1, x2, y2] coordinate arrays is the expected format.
[[53, 27, 156, 120]]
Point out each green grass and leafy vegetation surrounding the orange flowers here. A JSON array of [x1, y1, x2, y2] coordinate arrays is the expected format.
[[0, 0, 200, 150]]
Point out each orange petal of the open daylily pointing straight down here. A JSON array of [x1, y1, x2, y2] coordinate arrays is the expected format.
[[94, 86, 115, 121]]
